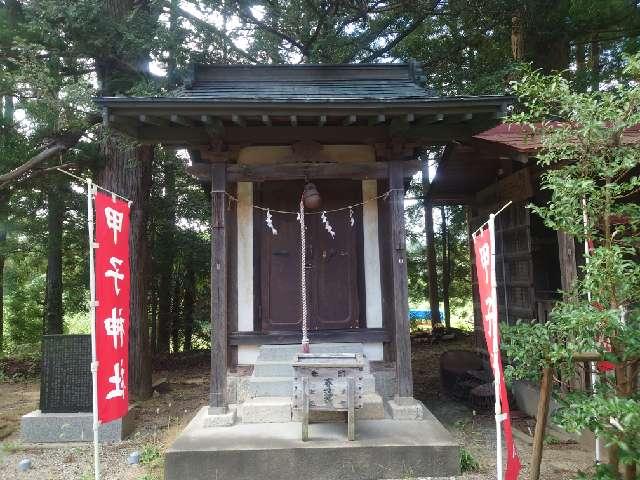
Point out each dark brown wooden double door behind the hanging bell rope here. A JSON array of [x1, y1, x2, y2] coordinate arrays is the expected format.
[[257, 181, 362, 332]]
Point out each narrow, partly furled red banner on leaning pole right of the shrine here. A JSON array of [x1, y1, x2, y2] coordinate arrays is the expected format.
[[473, 223, 521, 480]]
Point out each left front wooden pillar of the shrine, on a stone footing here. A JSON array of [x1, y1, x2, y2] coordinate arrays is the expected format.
[[209, 163, 227, 415]]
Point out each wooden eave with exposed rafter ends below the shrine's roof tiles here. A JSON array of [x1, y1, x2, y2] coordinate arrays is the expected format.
[[97, 96, 512, 147]]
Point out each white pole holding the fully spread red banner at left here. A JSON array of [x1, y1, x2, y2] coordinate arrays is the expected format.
[[87, 178, 100, 480]]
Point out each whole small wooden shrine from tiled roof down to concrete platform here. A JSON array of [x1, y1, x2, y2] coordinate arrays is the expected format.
[[98, 63, 522, 480]]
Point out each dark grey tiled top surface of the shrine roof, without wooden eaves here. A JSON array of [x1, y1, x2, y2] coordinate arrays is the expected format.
[[97, 62, 504, 108]]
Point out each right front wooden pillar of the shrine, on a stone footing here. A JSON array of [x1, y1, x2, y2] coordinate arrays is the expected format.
[[389, 161, 413, 398]]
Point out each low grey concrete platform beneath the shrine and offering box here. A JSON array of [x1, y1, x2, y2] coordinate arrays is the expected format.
[[165, 407, 460, 480]]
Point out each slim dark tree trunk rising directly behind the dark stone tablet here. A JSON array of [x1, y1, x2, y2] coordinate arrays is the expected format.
[[44, 179, 65, 335]]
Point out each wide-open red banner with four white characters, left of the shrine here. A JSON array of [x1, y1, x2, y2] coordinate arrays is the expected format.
[[95, 192, 129, 423]]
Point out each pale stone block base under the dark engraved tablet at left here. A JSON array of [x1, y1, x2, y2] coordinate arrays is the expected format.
[[20, 407, 133, 443]]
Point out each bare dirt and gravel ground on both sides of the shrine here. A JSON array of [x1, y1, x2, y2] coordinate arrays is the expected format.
[[0, 338, 592, 480]]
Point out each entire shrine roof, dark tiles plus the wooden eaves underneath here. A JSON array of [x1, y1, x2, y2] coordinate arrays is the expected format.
[[96, 62, 512, 145]]
